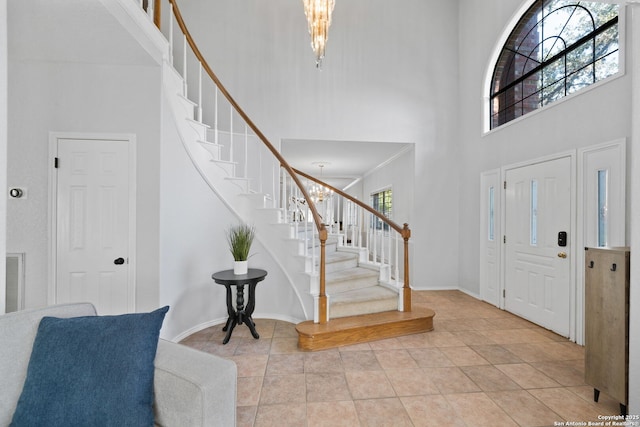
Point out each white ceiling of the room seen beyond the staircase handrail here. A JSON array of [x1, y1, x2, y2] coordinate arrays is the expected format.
[[280, 139, 413, 188]]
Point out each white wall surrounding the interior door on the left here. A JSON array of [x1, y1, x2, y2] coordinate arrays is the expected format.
[[7, 57, 160, 311]]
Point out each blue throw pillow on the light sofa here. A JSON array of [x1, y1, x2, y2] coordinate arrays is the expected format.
[[11, 306, 169, 427]]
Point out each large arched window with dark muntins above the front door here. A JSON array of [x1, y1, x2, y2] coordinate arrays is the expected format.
[[489, 0, 619, 129]]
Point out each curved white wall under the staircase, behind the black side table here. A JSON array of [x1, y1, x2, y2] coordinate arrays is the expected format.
[[160, 94, 306, 339]]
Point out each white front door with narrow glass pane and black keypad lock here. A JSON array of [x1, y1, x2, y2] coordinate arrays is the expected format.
[[504, 157, 572, 337]]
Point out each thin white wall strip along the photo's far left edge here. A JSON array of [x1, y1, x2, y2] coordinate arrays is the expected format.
[[0, 0, 8, 314]]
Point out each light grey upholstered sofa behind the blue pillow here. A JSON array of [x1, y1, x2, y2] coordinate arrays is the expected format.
[[0, 303, 237, 427]]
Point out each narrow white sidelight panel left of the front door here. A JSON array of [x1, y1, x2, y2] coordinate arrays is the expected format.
[[480, 169, 502, 307]]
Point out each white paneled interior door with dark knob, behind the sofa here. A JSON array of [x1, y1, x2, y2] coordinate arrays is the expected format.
[[55, 138, 134, 314]]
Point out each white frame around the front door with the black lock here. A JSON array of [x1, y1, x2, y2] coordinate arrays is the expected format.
[[500, 150, 582, 341]]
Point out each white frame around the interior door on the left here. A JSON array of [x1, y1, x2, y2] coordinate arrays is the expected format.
[[47, 132, 137, 312]]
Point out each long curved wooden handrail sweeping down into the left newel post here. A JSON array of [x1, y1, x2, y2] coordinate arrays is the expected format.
[[165, 0, 328, 323]]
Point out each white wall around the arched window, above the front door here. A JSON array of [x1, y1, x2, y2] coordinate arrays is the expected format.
[[459, 0, 631, 294]]
